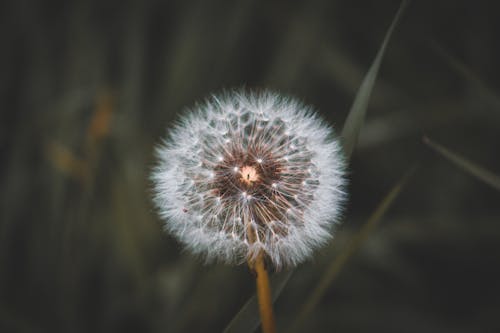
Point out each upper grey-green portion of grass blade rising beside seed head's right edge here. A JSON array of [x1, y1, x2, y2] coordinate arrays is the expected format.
[[341, 1, 408, 158]]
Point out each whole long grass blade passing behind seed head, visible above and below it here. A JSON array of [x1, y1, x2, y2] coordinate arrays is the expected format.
[[224, 0, 409, 333]]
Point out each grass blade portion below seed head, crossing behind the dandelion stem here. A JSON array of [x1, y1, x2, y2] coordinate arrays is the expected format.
[[224, 270, 293, 333]]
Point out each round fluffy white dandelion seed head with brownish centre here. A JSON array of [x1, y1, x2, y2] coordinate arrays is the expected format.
[[152, 91, 345, 269]]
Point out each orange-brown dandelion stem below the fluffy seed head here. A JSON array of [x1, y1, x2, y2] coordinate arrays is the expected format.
[[253, 253, 276, 333]]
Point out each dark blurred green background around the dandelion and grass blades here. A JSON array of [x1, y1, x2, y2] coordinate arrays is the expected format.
[[0, 0, 500, 332]]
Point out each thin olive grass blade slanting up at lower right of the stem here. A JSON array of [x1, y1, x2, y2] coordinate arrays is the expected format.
[[288, 167, 416, 332]]
